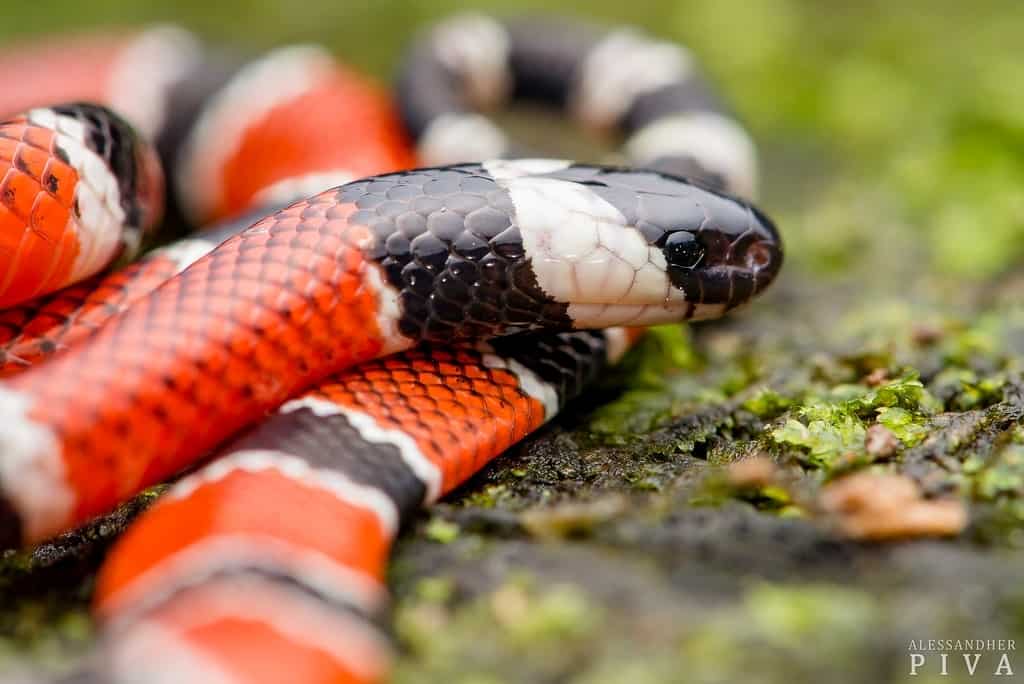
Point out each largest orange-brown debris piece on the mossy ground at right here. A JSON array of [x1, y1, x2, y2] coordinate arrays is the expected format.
[[818, 472, 968, 541]]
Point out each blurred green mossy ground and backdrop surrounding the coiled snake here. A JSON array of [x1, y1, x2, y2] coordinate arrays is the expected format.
[[6, 0, 1024, 684]]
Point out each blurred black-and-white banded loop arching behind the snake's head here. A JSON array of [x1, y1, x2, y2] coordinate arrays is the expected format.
[[395, 13, 758, 199]]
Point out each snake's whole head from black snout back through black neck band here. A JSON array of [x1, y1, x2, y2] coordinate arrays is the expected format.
[[344, 160, 782, 341]]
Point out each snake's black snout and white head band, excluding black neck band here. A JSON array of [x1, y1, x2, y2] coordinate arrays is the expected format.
[[487, 160, 782, 328]]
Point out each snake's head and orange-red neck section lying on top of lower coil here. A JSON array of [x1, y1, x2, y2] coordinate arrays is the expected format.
[[0, 154, 779, 540]]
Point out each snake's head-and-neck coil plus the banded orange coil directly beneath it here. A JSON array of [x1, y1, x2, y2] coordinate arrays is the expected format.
[[0, 12, 782, 682]]
